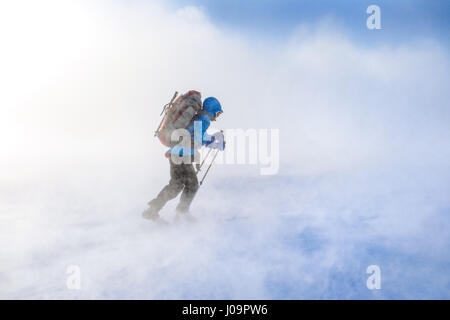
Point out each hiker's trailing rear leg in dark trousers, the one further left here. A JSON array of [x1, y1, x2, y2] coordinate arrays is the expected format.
[[149, 160, 184, 213]]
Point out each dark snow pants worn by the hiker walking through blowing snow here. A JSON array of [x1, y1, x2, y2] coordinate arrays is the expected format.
[[149, 159, 198, 212]]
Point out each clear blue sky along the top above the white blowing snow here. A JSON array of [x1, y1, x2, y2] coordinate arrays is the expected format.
[[172, 0, 450, 42]]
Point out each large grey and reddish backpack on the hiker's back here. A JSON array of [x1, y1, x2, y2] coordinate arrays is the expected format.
[[155, 90, 202, 147]]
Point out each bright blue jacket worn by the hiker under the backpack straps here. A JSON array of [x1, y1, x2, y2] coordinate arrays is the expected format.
[[166, 114, 213, 157]]
